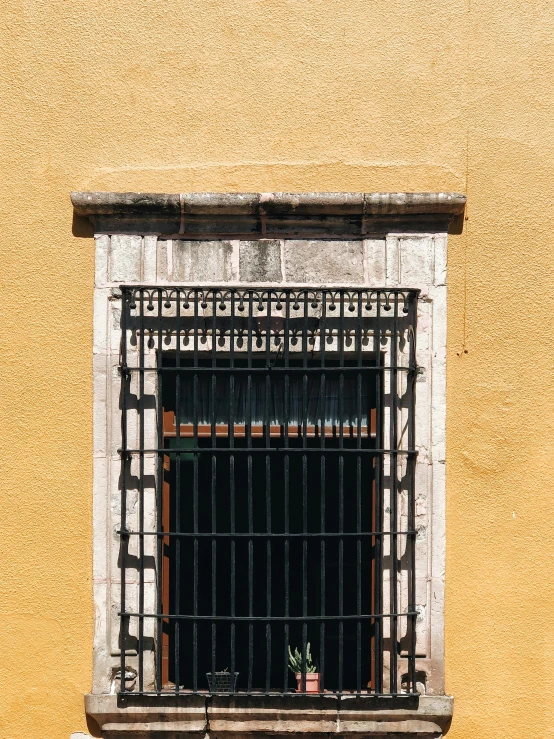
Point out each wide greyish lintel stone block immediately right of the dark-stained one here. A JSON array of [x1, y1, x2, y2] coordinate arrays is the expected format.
[[285, 239, 364, 284]]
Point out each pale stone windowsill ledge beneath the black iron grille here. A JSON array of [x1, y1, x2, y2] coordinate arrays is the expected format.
[[85, 695, 453, 739]]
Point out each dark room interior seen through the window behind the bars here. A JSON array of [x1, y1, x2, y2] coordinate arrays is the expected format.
[[158, 356, 376, 692]]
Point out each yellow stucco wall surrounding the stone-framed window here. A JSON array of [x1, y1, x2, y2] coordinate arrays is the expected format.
[[0, 0, 554, 739]]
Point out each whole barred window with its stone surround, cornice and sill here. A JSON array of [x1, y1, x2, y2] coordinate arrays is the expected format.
[[72, 193, 465, 739]]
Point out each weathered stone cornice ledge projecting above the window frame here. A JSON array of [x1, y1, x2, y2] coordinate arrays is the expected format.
[[71, 192, 466, 238]]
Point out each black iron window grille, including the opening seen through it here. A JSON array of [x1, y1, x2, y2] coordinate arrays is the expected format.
[[119, 286, 418, 696]]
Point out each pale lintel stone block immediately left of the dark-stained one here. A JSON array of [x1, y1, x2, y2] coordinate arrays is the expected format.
[[172, 240, 233, 282]]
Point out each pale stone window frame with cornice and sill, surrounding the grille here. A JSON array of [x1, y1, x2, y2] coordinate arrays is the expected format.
[[72, 193, 465, 737]]
